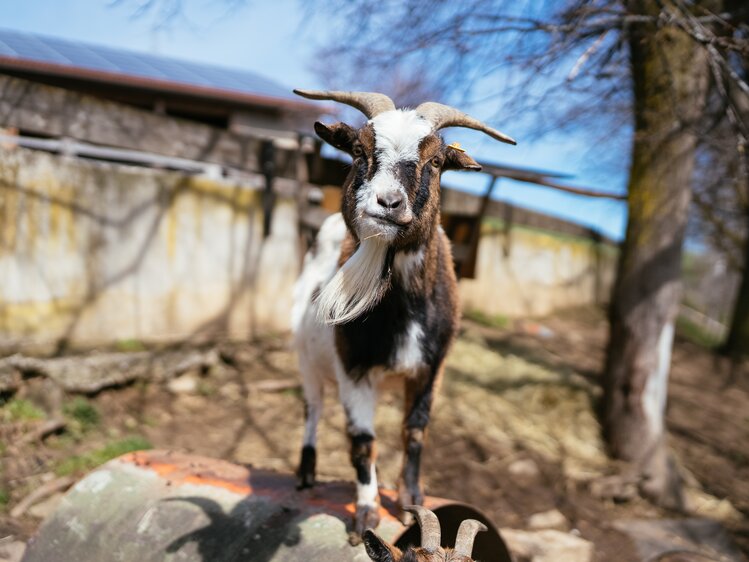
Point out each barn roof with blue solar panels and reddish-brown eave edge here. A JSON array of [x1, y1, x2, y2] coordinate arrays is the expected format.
[[0, 29, 311, 109]]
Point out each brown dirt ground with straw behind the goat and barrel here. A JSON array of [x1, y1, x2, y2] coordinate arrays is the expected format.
[[0, 310, 749, 561]]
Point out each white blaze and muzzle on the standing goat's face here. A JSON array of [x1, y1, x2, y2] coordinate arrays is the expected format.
[[356, 109, 432, 242]]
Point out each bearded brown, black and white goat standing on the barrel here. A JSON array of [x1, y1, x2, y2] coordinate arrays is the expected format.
[[292, 90, 514, 536]]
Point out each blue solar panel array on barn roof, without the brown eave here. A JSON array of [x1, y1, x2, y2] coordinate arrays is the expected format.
[[0, 29, 294, 99]]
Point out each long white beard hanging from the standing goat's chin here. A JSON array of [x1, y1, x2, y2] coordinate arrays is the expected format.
[[317, 237, 389, 325]]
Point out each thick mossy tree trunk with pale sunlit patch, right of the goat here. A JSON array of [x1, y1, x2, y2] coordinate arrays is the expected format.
[[602, 0, 708, 508]]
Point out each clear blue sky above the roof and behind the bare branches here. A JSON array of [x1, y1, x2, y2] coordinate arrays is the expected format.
[[0, 0, 628, 239]]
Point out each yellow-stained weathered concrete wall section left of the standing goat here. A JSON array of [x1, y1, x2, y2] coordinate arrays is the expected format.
[[0, 149, 298, 348]]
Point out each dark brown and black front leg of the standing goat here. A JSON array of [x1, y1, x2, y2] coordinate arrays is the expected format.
[[398, 370, 436, 524]]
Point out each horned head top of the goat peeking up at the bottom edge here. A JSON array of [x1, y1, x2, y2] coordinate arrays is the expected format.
[[363, 505, 486, 562]]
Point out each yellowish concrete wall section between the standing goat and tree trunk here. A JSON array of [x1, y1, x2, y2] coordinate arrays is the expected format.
[[460, 223, 616, 316]]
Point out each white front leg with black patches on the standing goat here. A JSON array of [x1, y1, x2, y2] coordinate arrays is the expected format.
[[339, 378, 380, 544]]
